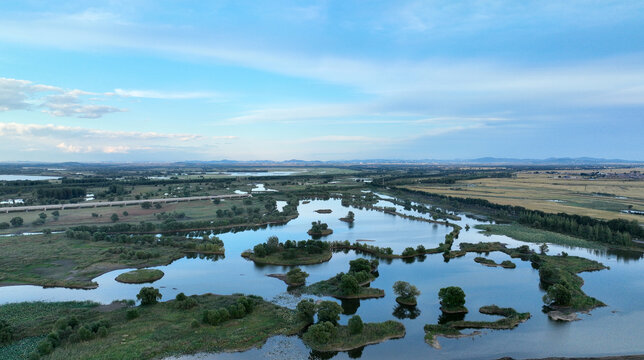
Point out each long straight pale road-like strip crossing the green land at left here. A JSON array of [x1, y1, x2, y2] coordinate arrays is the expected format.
[[0, 194, 251, 213]]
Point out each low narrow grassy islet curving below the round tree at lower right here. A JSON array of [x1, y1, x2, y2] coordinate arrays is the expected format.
[[425, 305, 530, 349]]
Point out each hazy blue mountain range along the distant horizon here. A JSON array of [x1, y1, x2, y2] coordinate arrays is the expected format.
[[0, 157, 644, 168]]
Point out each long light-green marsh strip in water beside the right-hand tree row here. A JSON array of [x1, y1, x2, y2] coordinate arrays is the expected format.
[[474, 223, 605, 249]]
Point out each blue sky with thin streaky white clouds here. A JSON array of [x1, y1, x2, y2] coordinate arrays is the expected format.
[[0, 0, 644, 162]]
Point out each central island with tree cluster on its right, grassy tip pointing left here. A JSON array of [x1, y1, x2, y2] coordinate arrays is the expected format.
[[301, 258, 385, 299]]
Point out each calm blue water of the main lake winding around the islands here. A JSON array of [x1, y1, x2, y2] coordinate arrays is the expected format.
[[0, 200, 644, 359]]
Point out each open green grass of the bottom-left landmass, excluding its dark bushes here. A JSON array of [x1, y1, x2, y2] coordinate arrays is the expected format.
[[0, 294, 305, 359]]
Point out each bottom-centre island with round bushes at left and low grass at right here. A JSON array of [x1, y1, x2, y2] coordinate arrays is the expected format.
[[297, 299, 405, 351]]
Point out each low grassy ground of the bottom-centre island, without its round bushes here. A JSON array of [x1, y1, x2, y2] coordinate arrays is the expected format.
[[302, 320, 405, 351]]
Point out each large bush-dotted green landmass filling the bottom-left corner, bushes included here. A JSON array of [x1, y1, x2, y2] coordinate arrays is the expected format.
[[0, 288, 306, 360]]
